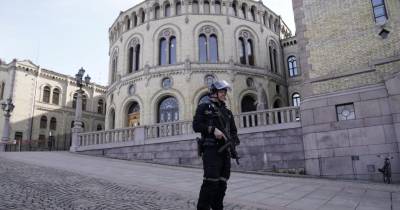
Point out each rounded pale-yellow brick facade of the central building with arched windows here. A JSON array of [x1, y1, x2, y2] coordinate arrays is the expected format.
[[106, 1, 290, 129]]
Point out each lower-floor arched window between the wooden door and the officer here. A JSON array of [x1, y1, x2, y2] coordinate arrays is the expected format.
[[158, 96, 179, 123]]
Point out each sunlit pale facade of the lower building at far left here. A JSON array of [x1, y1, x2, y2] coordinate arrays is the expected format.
[[0, 60, 106, 150]]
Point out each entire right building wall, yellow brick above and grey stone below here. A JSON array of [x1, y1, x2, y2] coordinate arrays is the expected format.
[[289, 0, 400, 180]]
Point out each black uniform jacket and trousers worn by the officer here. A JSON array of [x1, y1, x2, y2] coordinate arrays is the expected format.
[[193, 100, 239, 210]]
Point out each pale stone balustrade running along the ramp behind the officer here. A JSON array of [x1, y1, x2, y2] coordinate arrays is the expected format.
[[78, 107, 300, 151]]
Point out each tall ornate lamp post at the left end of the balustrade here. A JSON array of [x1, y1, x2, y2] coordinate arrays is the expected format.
[[69, 68, 90, 152]]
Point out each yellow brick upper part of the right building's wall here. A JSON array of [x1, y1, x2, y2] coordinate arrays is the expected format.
[[303, 0, 400, 94]]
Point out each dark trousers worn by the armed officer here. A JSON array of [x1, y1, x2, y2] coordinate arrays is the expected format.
[[197, 146, 231, 210]]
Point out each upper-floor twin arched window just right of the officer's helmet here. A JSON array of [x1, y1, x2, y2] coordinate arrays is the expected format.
[[239, 31, 255, 66]]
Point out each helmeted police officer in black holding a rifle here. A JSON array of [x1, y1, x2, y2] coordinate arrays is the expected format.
[[193, 80, 240, 210]]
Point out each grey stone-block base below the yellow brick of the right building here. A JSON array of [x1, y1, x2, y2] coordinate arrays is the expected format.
[[301, 84, 400, 180]]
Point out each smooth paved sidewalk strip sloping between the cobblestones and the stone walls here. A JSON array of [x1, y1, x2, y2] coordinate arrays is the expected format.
[[0, 152, 400, 210]]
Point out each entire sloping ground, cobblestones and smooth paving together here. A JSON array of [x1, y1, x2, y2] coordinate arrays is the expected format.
[[0, 152, 400, 210]]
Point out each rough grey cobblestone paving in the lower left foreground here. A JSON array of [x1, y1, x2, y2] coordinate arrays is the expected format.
[[0, 159, 258, 210]]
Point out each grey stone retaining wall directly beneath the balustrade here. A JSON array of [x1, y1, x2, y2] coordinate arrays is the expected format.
[[79, 127, 304, 173]]
